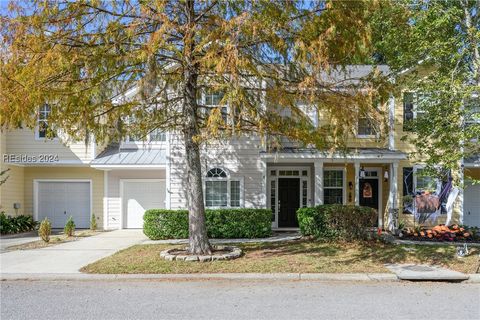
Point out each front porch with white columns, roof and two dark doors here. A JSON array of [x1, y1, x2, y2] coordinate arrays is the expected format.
[[262, 149, 406, 230]]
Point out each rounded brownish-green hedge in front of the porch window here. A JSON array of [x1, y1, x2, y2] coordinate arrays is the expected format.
[[297, 204, 377, 240]]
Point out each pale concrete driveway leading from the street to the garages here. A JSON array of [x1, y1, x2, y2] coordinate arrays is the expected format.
[[0, 230, 147, 274]]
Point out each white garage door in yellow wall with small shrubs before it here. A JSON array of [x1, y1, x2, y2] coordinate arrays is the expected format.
[[36, 181, 91, 229]]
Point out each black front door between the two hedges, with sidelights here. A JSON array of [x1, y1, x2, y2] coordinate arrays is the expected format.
[[278, 178, 300, 228]]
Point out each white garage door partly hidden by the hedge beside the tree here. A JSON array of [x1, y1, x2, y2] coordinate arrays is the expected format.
[[122, 179, 165, 228]]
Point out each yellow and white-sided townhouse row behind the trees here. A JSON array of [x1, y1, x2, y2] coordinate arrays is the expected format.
[[0, 66, 480, 229]]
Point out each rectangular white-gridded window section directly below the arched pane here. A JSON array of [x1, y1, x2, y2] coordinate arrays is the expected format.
[[205, 179, 241, 207]]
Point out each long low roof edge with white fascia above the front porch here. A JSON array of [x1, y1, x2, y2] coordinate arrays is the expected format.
[[261, 148, 407, 162]]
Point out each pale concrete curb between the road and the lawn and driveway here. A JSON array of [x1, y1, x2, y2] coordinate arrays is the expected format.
[[0, 273, 400, 282]]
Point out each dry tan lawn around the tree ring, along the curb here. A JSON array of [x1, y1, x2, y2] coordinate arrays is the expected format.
[[81, 241, 479, 273]]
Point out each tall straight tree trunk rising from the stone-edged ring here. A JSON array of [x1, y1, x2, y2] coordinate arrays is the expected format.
[[183, 1, 212, 254]]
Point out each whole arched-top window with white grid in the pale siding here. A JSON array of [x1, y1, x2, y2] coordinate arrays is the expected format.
[[205, 168, 243, 208]]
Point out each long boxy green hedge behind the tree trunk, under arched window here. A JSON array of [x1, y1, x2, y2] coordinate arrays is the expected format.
[[143, 208, 272, 240]]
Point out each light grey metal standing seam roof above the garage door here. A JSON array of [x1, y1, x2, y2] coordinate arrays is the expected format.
[[90, 146, 167, 165]]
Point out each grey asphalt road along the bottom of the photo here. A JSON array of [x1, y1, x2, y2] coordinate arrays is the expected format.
[[0, 280, 480, 320]]
